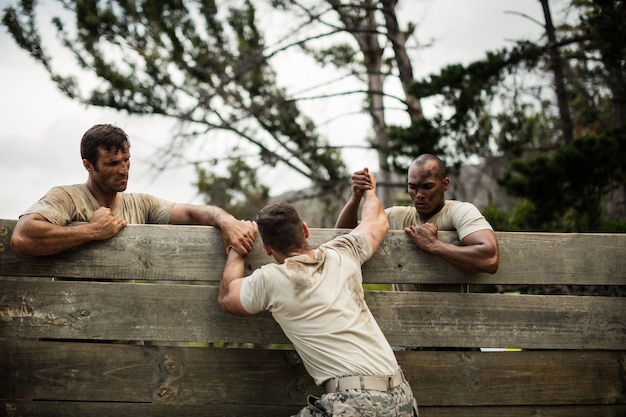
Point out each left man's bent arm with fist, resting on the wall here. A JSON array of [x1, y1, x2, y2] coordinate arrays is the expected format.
[[11, 207, 127, 256]]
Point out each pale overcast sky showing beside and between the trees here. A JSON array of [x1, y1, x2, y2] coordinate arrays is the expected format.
[[0, 0, 543, 219]]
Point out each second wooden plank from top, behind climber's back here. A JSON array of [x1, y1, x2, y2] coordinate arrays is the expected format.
[[0, 279, 626, 350]]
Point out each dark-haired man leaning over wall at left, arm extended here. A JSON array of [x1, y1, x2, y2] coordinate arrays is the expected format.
[[11, 124, 254, 255]]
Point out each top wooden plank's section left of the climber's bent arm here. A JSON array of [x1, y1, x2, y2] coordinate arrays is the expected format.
[[0, 221, 225, 280]]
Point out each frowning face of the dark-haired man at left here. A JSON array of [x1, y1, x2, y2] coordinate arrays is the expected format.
[[87, 147, 130, 192]]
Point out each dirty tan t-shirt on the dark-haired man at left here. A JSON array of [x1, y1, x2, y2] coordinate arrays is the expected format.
[[22, 184, 174, 226]]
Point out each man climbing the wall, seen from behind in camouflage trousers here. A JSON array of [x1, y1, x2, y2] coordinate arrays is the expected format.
[[218, 171, 418, 417]]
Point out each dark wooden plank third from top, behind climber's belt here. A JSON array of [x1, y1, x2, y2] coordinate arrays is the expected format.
[[0, 339, 626, 407]]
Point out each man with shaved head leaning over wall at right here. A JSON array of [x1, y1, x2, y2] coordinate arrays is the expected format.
[[335, 154, 500, 290]]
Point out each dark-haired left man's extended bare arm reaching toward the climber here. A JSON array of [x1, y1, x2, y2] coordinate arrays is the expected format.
[[170, 204, 255, 256]]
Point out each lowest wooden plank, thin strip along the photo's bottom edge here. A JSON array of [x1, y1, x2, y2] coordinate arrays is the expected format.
[[0, 400, 626, 417]]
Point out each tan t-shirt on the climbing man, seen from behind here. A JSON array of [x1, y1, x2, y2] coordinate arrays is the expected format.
[[240, 233, 398, 385]]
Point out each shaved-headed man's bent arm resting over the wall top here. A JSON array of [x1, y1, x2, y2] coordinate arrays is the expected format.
[[404, 223, 500, 274]]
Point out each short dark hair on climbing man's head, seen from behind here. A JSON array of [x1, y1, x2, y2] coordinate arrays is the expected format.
[[256, 203, 306, 254]]
